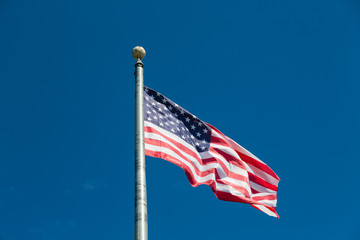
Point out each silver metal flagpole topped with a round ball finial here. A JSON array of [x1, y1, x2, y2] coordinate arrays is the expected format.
[[132, 46, 148, 240]]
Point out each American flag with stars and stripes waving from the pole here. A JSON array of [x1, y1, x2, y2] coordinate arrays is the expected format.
[[144, 87, 280, 217]]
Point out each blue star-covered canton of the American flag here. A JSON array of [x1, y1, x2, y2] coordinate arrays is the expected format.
[[144, 87, 211, 152]]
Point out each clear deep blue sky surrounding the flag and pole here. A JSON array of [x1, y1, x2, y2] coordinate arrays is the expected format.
[[0, 0, 360, 240]]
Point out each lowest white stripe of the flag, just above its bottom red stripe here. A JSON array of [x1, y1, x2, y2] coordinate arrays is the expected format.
[[145, 143, 249, 197]]
